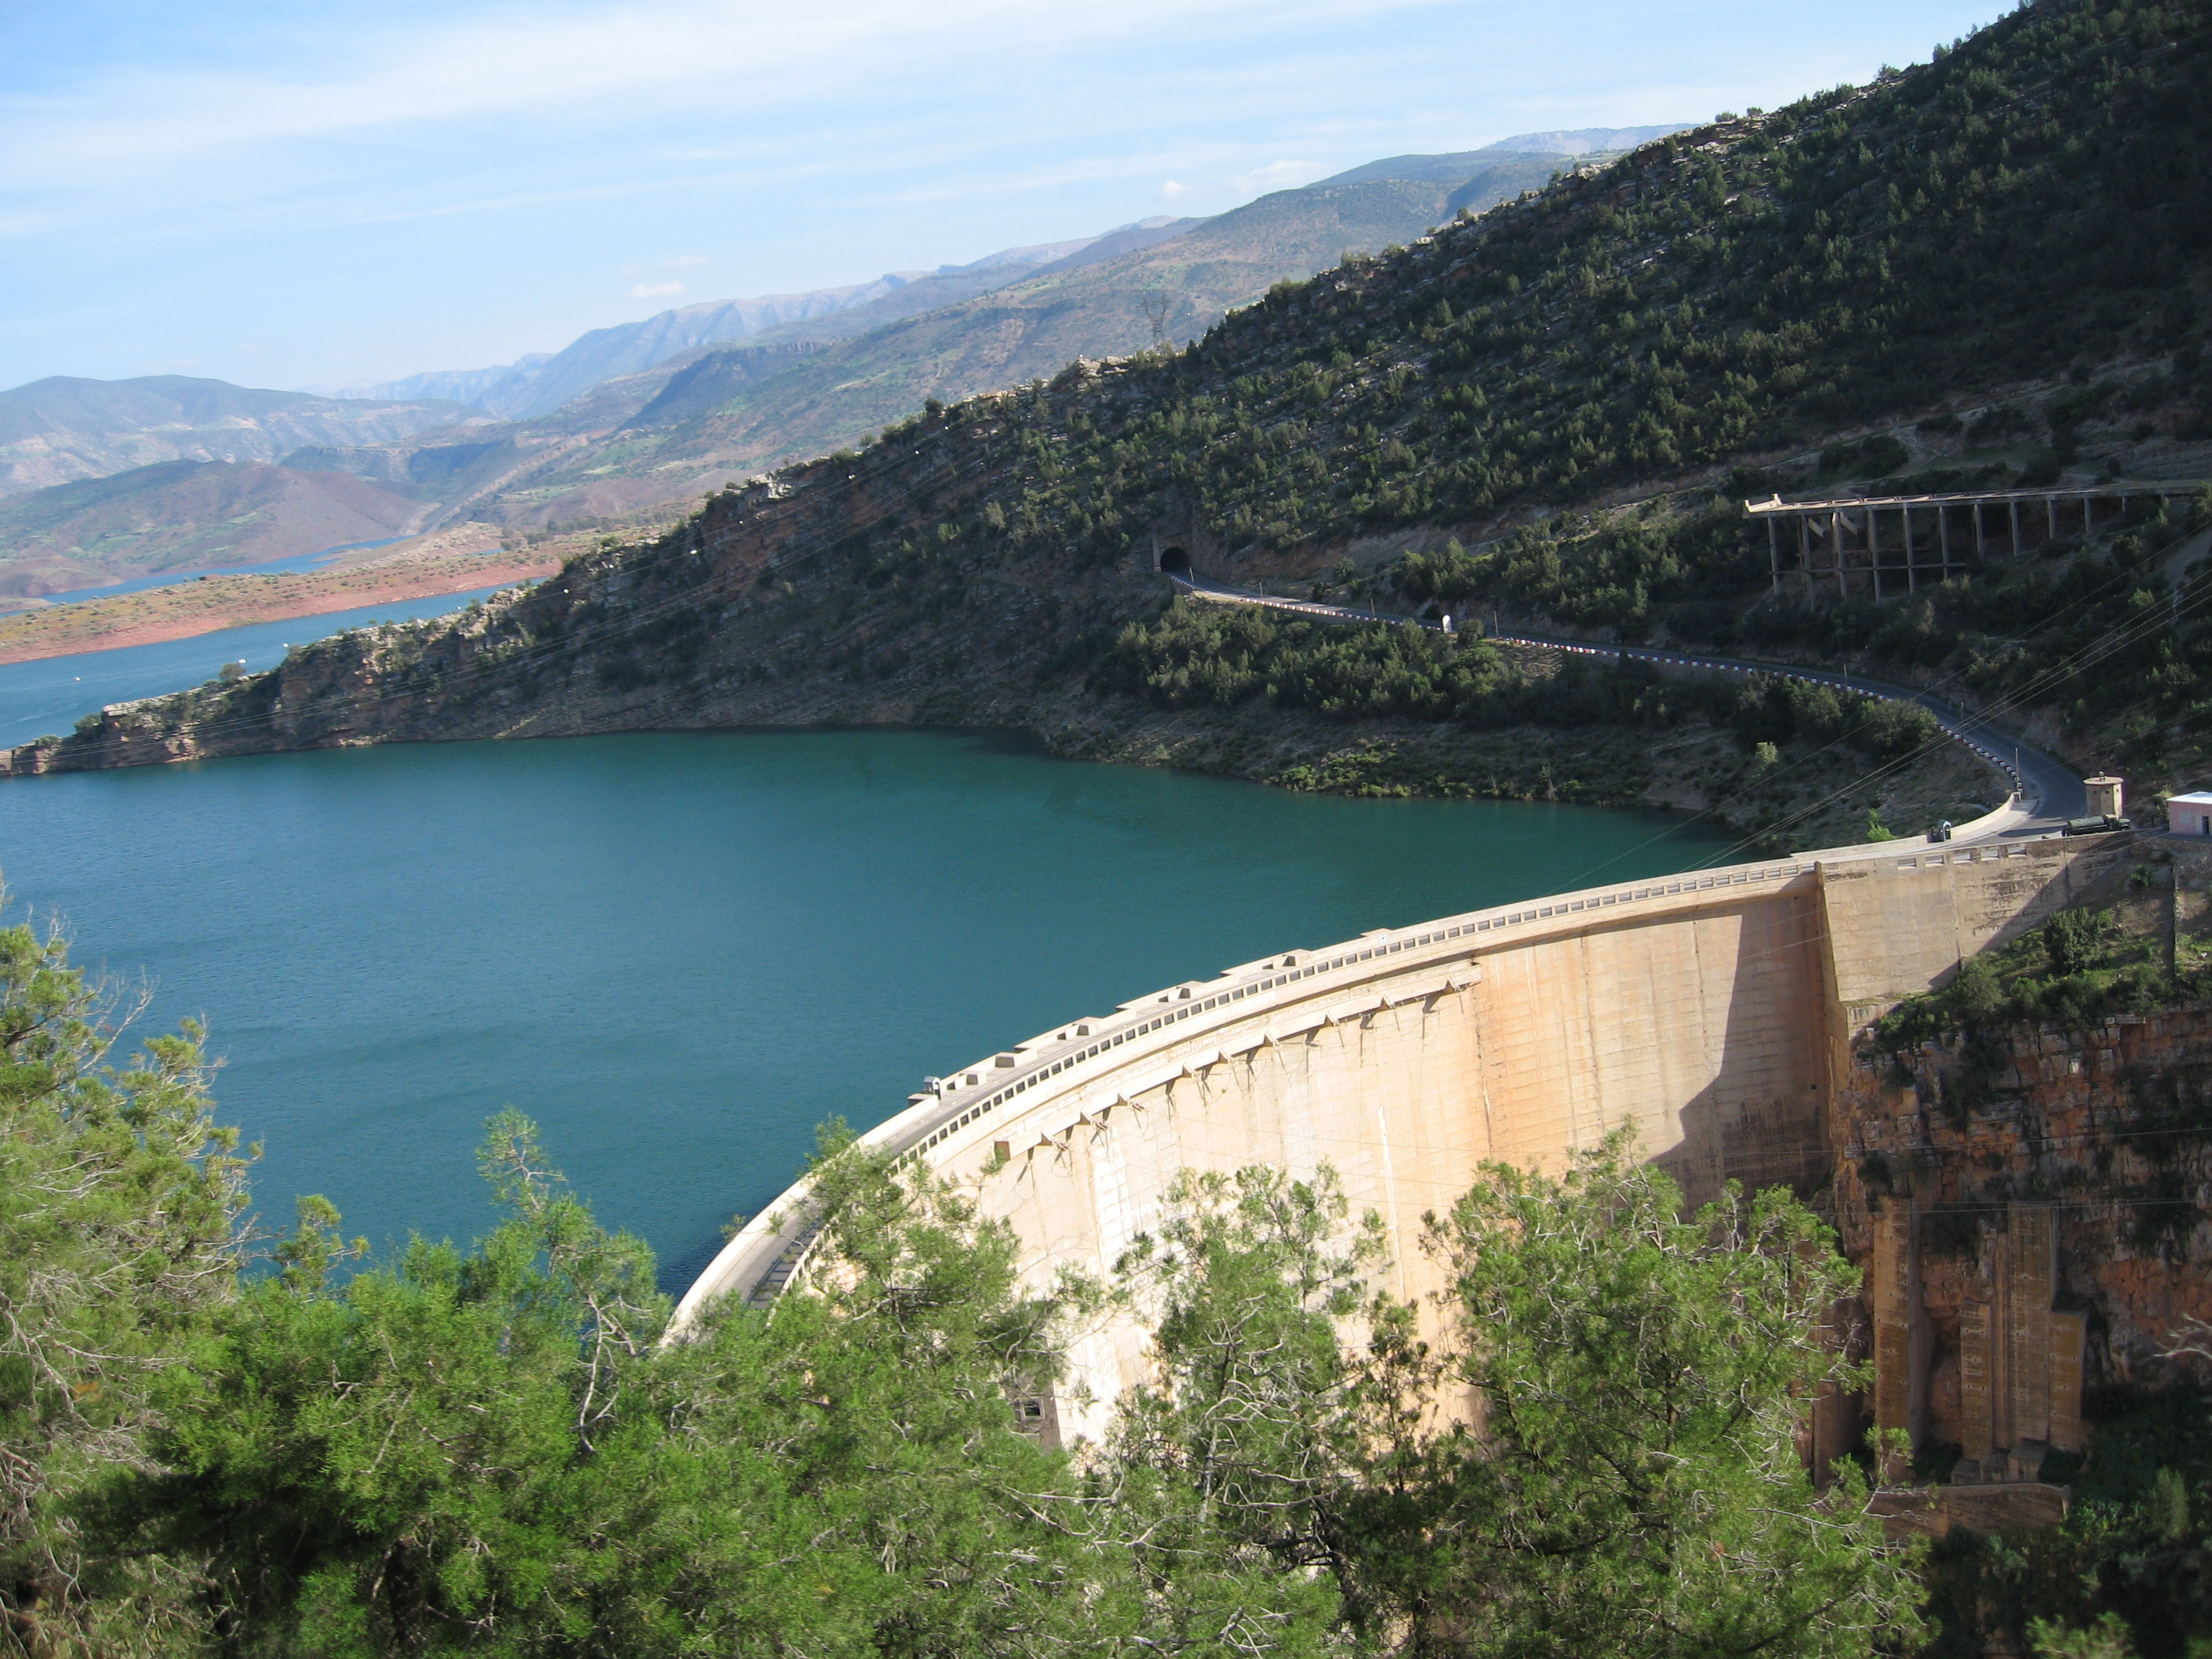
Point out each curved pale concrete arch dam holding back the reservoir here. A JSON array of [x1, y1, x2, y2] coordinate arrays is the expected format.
[[677, 836, 2126, 1438]]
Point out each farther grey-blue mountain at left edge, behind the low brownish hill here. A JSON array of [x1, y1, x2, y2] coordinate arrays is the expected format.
[[0, 374, 471, 495]]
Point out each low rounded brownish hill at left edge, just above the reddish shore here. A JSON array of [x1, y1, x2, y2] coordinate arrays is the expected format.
[[0, 460, 427, 595]]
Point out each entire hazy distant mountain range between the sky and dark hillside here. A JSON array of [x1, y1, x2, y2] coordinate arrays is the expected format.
[[0, 128, 1677, 593]]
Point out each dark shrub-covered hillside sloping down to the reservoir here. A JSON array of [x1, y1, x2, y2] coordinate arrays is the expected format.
[[18, 0, 2212, 840]]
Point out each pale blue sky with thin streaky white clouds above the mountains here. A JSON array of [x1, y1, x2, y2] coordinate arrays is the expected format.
[[0, 0, 2004, 387]]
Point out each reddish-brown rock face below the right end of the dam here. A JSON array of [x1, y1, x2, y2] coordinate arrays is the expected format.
[[1830, 1009, 2212, 1482]]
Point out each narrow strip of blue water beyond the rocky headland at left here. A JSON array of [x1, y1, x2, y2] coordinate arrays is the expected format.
[[0, 586, 513, 747]]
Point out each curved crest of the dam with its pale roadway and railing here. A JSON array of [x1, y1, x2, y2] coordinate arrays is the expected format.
[[668, 832, 2062, 1336]]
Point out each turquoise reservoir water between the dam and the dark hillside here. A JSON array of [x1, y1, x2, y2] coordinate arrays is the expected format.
[[0, 730, 1721, 1285]]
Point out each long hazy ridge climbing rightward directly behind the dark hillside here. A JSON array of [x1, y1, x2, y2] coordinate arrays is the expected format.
[[81, 128, 1665, 548]]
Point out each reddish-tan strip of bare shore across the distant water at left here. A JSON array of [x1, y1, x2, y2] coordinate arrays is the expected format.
[[0, 555, 559, 666]]
